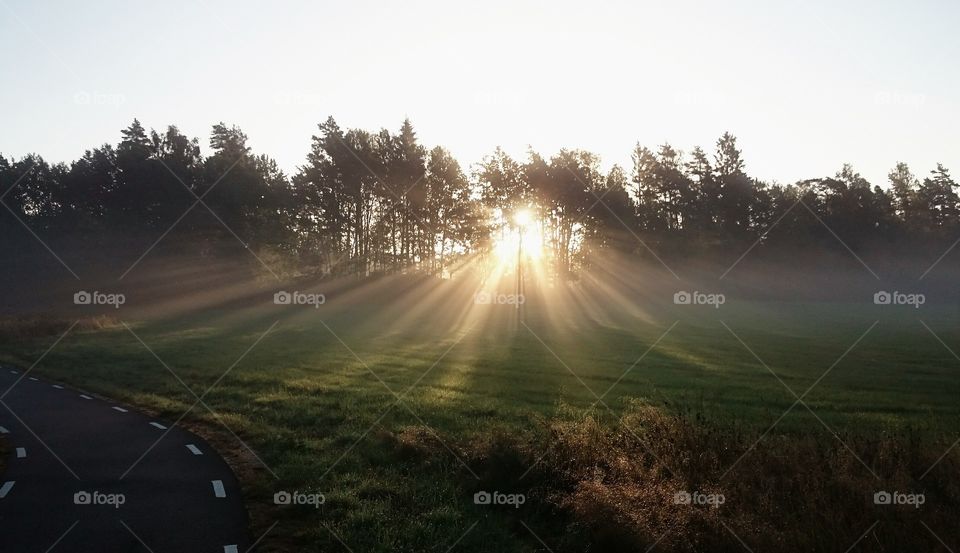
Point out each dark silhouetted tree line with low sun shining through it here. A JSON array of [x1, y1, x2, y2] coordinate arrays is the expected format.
[[0, 117, 960, 275]]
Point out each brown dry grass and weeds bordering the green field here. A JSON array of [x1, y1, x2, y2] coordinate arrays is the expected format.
[[394, 402, 960, 553]]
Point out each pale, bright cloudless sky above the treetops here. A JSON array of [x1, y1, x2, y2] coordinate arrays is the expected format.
[[0, 0, 960, 184]]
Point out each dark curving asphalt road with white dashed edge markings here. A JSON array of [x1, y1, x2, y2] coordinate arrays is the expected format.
[[0, 367, 250, 553]]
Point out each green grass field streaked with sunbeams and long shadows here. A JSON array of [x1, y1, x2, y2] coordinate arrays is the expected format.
[[0, 282, 960, 552]]
